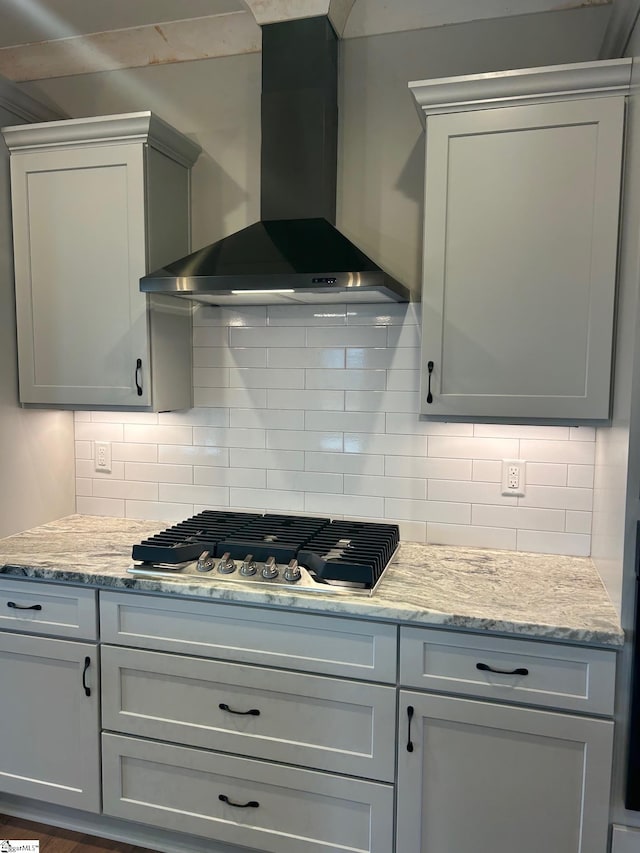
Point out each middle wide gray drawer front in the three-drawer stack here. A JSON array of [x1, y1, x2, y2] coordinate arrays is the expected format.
[[102, 646, 396, 782]]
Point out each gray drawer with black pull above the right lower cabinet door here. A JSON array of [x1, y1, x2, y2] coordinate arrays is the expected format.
[[400, 628, 616, 716]]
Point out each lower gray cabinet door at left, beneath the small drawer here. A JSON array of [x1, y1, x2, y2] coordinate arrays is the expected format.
[[0, 634, 100, 812]]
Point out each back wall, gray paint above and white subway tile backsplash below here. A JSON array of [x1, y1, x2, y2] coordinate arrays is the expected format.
[[21, 10, 602, 555]]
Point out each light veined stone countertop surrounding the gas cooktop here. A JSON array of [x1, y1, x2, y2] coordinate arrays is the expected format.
[[0, 515, 623, 647]]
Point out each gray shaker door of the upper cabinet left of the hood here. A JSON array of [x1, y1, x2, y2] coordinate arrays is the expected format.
[[11, 144, 151, 406]]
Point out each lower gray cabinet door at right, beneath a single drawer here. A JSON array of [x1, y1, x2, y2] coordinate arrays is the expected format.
[[396, 691, 613, 853]]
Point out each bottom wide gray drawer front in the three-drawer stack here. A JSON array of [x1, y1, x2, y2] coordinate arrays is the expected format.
[[102, 734, 393, 853]]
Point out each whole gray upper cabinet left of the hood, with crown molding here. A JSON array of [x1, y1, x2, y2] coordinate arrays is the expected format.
[[3, 112, 200, 411]]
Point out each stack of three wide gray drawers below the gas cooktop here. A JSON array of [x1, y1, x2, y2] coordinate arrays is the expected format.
[[101, 593, 397, 853]]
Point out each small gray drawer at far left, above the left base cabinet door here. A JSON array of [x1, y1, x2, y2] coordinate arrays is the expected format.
[[0, 578, 98, 640]]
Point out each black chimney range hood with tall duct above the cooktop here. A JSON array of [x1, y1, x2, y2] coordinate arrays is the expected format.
[[140, 17, 409, 305]]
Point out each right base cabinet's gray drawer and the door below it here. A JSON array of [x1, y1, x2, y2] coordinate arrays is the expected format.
[[396, 628, 615, 853]]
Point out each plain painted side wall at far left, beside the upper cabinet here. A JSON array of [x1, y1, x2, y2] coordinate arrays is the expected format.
[[0, 95, 75, 536]]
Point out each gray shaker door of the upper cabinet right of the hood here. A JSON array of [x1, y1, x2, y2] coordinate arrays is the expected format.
[[421, 97, 624, 420]]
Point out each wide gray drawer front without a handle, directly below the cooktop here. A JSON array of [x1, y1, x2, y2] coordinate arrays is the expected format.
[[100, 592, 397, 684]]
